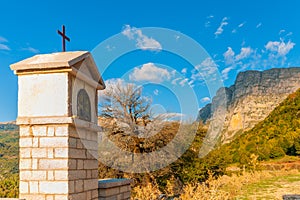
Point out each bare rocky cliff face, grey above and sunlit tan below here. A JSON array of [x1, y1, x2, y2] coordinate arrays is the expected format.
[[198, 68, 300, 143]]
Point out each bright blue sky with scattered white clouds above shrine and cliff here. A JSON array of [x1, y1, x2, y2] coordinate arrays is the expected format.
[[0, 0, 300, 122]]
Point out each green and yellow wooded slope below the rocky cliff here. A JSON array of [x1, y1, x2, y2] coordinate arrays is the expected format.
[[206, 89, 300, 165]]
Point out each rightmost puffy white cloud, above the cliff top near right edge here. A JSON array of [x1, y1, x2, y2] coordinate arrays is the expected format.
[[265, 40, 296, 57]]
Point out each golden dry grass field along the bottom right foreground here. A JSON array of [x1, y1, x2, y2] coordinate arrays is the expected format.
[[132, 170, 300, 200]]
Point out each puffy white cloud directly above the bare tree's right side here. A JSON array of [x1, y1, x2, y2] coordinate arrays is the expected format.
[[129, 63, 171, 83]]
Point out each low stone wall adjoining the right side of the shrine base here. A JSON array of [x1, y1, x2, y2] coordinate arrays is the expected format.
[[98, 179, 131, 200]]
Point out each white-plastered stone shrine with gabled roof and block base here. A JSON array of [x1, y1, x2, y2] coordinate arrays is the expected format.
[[11, 51, 130, 200]]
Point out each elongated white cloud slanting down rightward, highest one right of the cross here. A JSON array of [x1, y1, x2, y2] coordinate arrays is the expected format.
[[122, 25, 162, 51]]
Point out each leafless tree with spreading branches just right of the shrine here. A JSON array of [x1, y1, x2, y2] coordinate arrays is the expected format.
[[100, 81, 151, 136]]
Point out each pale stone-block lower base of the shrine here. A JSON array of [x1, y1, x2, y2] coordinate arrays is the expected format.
[[19, 124, 98, 200]]
